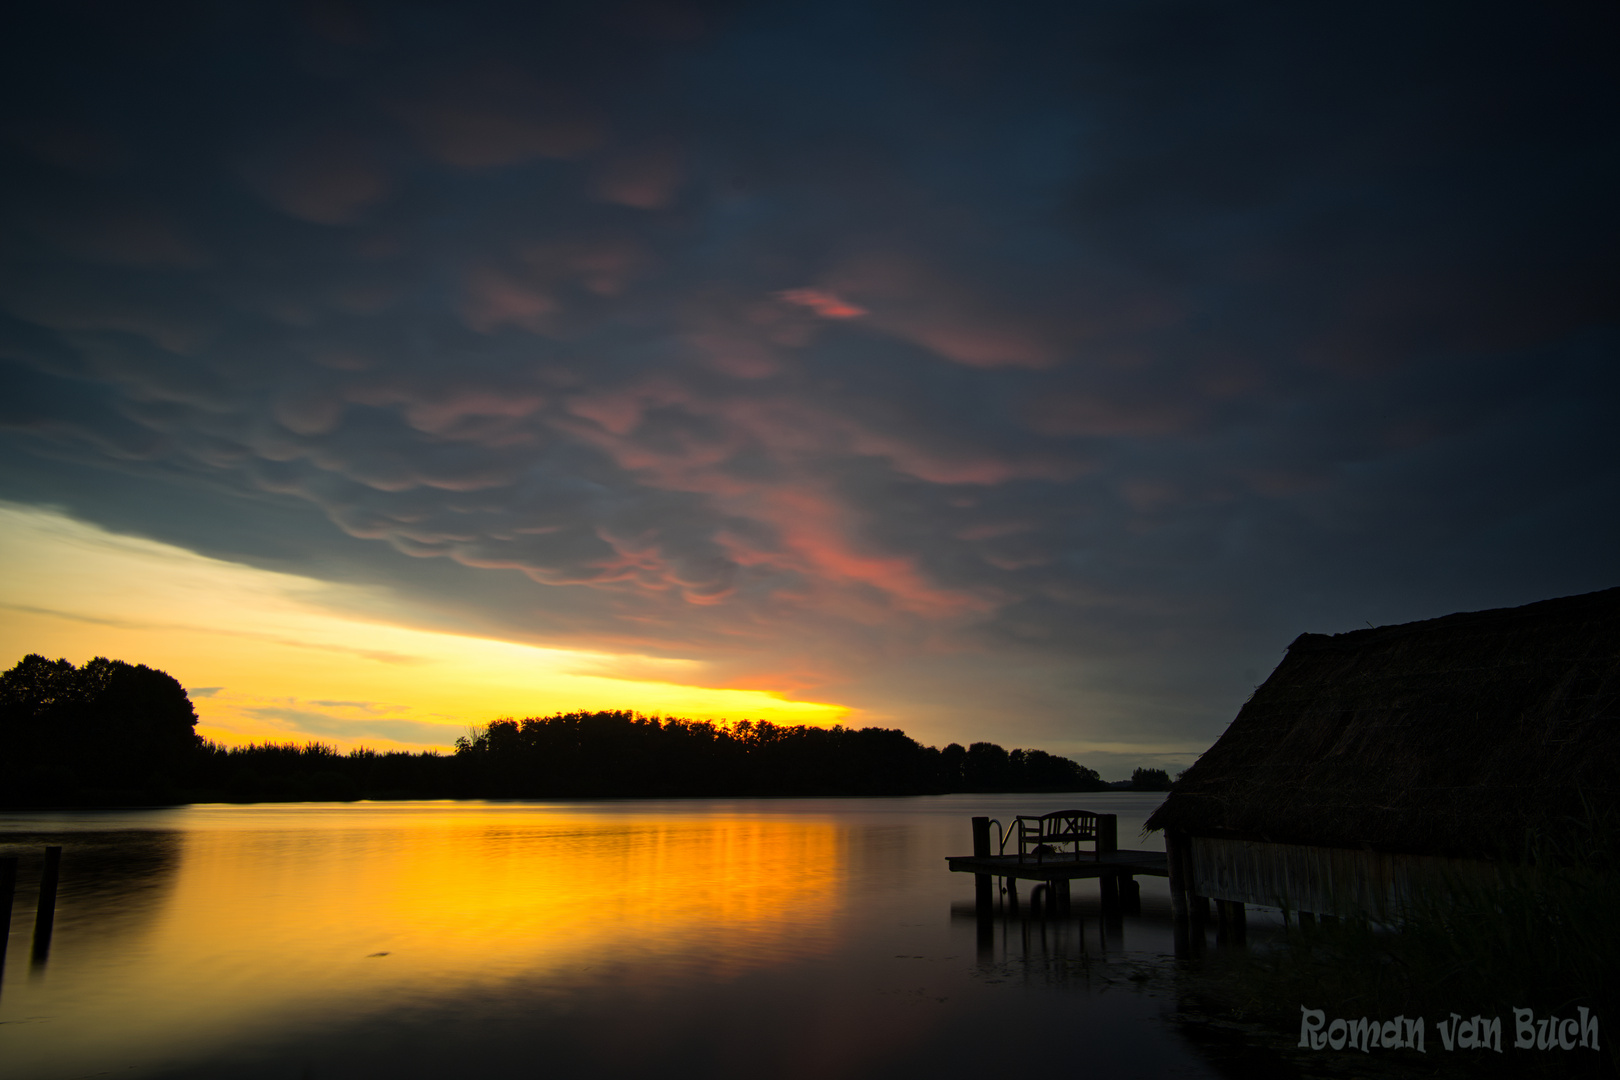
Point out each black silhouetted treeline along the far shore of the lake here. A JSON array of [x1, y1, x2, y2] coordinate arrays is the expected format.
[[0, 656, 1168, 806]]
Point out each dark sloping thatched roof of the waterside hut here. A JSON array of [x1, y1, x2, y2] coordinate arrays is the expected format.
[[1147, 588, 1620, 855]]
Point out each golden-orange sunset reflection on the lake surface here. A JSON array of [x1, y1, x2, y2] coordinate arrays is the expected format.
[[0, 803, 847, 1077]]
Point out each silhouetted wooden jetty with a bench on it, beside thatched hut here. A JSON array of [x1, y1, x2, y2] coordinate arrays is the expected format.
[[946, 810, 1170, 913]]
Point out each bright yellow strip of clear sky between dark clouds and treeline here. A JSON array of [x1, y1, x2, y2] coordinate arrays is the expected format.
[[0, 504, 851, 750]]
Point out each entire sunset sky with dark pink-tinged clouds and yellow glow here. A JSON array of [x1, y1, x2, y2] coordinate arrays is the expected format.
[[0, 0, 1620, 779]]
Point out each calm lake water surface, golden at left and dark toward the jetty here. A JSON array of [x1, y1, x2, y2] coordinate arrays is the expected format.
[[0, 793, 1217, 1080]]
